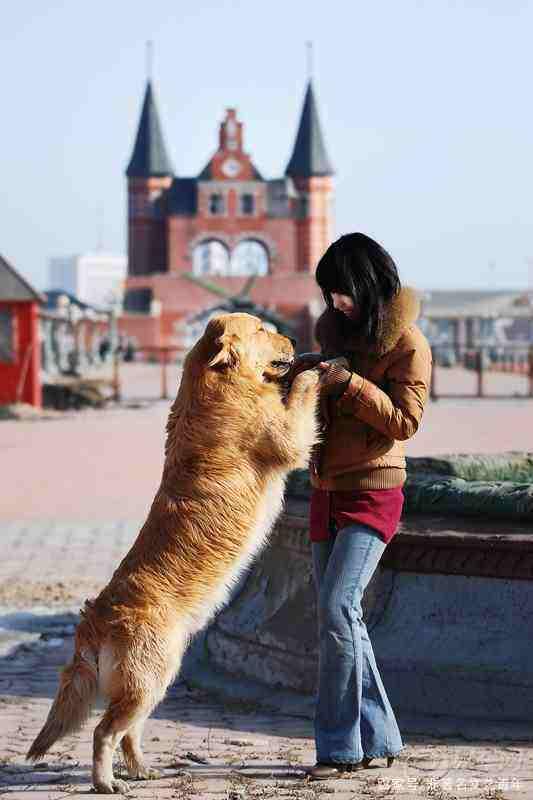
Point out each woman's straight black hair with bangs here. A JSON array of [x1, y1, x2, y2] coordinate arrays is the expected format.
[[315, 233, 401, 342]]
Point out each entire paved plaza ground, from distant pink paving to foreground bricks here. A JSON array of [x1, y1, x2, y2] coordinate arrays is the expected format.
[[0, 365, 533, 800]]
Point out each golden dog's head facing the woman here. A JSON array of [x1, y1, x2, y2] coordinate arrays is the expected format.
[[191, 313, 294, 381]]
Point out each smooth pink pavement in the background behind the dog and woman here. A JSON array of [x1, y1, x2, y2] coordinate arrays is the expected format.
[[0, 382, 533, 522]]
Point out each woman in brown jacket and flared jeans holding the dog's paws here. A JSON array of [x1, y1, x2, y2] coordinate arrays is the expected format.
[[296, 233, 431, 780]]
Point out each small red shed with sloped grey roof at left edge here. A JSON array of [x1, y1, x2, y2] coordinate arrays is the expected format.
[[0, 256, 44, 406]]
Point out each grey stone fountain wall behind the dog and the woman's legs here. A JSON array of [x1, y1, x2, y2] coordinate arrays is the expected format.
[[187, 454, 533, 736]]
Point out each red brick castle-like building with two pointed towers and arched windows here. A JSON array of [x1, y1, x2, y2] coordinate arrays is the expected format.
[[119, 82, 333, 346]]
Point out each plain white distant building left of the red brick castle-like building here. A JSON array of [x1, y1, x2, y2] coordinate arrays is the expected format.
[[49, 253, 128, 308]]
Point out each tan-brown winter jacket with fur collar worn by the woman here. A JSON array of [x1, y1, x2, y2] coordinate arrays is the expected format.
[[311, 287, 431, 491]]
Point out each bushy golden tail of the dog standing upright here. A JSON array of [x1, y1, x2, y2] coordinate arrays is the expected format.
[[26, 622, 98, 761]]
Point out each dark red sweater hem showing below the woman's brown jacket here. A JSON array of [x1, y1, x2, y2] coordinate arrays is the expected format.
[[309, 486, 403, 543]]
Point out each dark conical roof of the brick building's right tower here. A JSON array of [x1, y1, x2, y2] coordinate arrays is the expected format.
[[285, 81, 333, 178]]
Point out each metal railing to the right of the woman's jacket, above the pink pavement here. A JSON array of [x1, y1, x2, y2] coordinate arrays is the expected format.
[[431, 343, 533, 400]]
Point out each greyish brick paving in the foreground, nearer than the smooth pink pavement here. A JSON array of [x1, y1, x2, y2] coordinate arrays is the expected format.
[[0, 520, 533, 800]]
